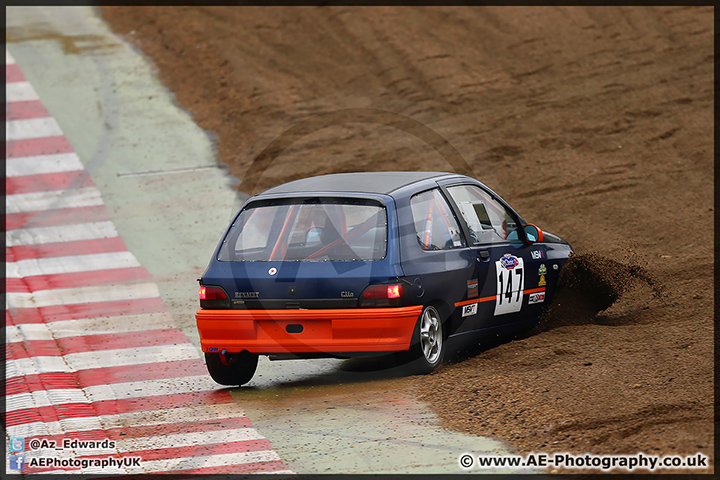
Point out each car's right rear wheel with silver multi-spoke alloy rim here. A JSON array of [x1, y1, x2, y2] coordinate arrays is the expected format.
[[403, 305, 445, 374]]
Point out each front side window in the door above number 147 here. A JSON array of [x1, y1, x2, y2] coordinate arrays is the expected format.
[[448, 185, 520, 245]]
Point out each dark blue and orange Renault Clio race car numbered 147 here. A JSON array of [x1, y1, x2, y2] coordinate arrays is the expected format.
[[196, 172, 573, 385]]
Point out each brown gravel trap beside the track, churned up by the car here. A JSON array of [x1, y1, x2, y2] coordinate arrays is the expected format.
[[101, 6, 714, 472]]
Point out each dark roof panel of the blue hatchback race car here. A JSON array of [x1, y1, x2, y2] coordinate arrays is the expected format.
[[261, 172, 457, 195]]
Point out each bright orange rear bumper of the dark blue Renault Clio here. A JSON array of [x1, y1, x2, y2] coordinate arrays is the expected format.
[[195, 305, 422, 354]]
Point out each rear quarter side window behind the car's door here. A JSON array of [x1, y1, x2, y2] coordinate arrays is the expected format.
[[410, 189, 465, 250]]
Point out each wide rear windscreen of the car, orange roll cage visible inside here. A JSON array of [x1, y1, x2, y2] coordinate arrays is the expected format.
[[218, 198, 387, 262]]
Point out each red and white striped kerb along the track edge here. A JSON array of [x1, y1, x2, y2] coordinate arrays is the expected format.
[[5, 48, 291, 474]]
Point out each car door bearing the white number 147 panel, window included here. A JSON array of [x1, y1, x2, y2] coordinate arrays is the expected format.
[[444, 184, 544, 330]]
